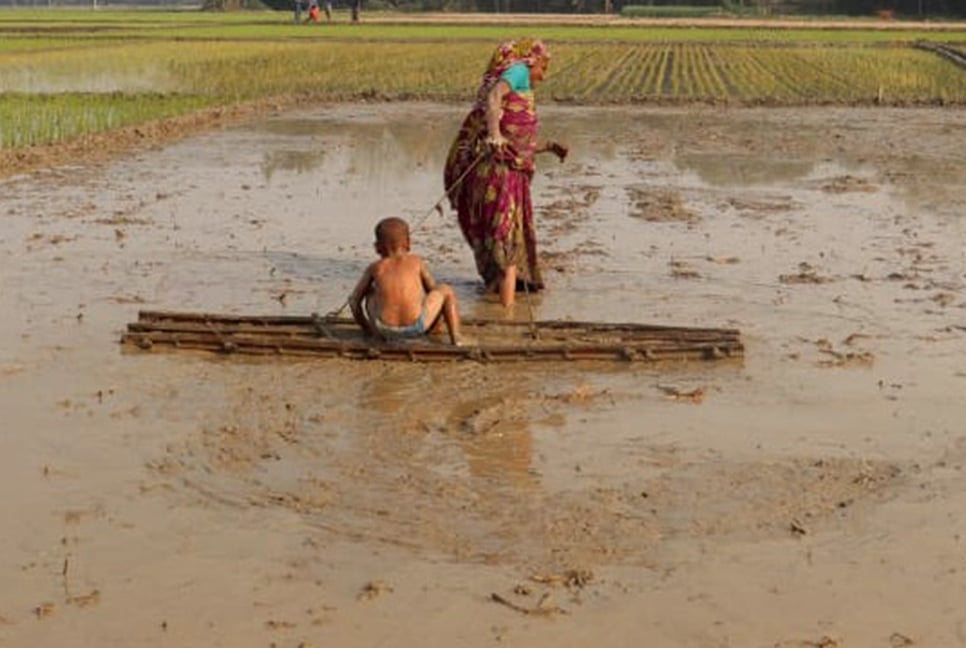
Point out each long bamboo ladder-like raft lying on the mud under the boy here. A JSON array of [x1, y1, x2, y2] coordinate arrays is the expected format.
[[121, 311, 744, 362]]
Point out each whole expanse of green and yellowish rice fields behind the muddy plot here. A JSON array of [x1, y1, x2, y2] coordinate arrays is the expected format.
[[0, 10, 966, 149]]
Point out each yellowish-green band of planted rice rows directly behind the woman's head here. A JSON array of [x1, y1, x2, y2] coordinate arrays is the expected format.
[[0, 42, 966, 102]]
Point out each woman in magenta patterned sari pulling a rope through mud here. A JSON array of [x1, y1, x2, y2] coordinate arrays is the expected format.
[[444, 39, 567, 306]]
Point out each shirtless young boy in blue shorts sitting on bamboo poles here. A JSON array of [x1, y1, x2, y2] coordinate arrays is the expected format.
[[349, 218, 460, 345]]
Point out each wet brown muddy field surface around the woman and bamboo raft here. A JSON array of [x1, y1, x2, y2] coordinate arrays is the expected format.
[[0, 104, 966, 648]]
